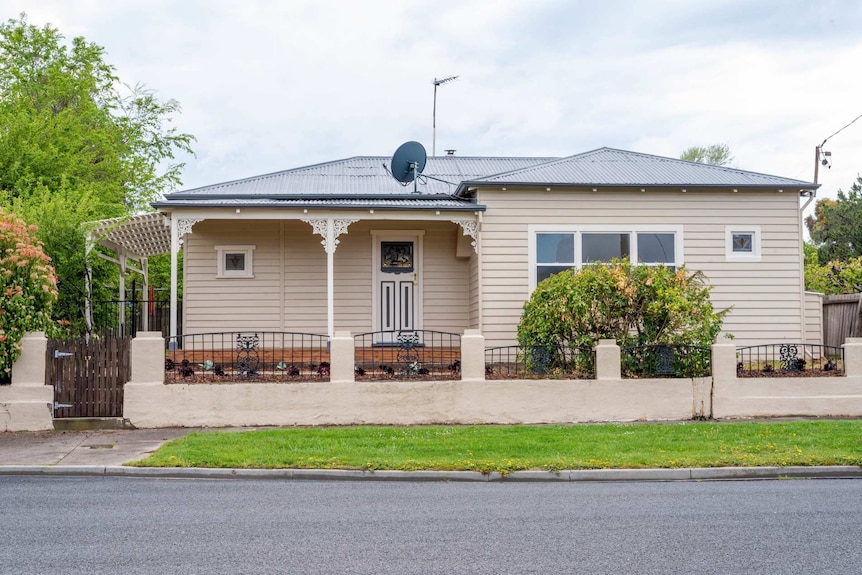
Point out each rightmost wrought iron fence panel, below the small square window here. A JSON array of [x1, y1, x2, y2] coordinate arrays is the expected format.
[[736, 342, 844, 377]]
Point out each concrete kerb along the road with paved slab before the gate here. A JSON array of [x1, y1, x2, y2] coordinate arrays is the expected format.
[[0, 428, 862, 482]]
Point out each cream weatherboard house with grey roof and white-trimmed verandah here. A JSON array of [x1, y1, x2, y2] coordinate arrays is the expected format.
[[135, 148, 819, 345]]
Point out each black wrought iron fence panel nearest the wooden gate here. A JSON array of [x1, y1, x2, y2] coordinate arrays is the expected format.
[[165, 331, 330, 383]]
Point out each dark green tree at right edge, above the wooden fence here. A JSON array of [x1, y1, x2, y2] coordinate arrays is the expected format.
[[805, 176, 862, 264]]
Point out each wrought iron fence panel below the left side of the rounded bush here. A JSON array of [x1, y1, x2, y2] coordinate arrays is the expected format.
[[485, 345, 596, 379]]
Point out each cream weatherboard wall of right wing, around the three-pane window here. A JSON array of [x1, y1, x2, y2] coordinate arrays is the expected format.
[[478, 188, 805, 346]]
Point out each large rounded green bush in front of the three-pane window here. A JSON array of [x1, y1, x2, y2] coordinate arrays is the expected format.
[[518, 260, 729, 350]]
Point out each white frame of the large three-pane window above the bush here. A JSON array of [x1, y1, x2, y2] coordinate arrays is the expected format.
[[527, 224, 684, 293]]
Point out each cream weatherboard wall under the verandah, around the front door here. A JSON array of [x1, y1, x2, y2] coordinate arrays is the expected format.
[[183, 219, 471, 334]]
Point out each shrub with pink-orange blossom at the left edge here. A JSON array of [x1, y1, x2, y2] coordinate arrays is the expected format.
[[0, 208, 57, 381]]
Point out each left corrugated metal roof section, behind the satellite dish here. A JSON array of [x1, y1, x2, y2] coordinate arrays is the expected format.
[[158, 156, 556, 205]]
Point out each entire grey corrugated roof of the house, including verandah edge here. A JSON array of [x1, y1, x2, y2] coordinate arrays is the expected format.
[[153, 148, 818, 210]]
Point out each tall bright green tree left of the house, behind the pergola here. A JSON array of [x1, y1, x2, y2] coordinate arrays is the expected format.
[[0, 14, 193, 330]]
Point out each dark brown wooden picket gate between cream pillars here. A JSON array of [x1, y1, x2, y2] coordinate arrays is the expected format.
[[45, 334, 132, 419]]
